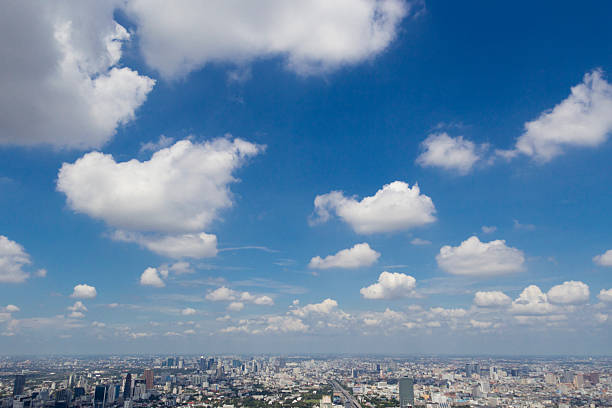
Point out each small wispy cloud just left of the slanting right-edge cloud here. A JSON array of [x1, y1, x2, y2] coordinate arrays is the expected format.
[[416, 133, 488, 174]]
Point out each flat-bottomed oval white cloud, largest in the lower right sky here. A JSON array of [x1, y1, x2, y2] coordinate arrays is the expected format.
[[436, 236, 525, 277]]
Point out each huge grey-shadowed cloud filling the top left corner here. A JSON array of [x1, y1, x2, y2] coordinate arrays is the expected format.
[[0, 1, 155, 148]]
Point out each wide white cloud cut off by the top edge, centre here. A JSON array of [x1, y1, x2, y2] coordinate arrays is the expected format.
[[127, 0, 409, 77]]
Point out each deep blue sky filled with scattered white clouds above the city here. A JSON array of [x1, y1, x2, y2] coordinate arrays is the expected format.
[[0, 0, 612, 355]]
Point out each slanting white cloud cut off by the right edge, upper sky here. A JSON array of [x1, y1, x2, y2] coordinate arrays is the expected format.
[[502, 70, 612, 162]]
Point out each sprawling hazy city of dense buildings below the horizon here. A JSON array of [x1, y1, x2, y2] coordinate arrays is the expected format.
[[0, 356, 612, 408]]
